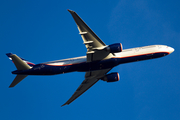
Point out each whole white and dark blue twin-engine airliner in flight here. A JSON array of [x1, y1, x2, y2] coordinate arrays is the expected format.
[[6, 10, 174, 106]]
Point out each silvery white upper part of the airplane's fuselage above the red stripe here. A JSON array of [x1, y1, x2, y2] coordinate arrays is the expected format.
[[44, 45, 174, 66]]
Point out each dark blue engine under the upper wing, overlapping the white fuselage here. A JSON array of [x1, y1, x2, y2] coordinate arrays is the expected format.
[[106, 43, 123, 53]]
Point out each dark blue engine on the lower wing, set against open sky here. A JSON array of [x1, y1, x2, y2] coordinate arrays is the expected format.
[[101, 72, 119, 82]]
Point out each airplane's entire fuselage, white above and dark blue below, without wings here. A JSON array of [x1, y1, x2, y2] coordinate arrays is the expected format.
[[13, 45, 174, 75]]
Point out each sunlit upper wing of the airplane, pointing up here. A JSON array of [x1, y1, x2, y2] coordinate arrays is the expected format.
[[68, 10, 112, 62]]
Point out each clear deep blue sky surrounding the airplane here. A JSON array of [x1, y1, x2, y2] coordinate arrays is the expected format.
[[0, 0, 180, 120]]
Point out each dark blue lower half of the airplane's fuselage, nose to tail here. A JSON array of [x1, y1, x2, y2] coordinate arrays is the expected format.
[[12, 52, 169, 75]]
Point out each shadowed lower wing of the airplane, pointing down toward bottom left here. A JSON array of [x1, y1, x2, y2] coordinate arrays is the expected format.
[[62, 69, 111, 106]]
